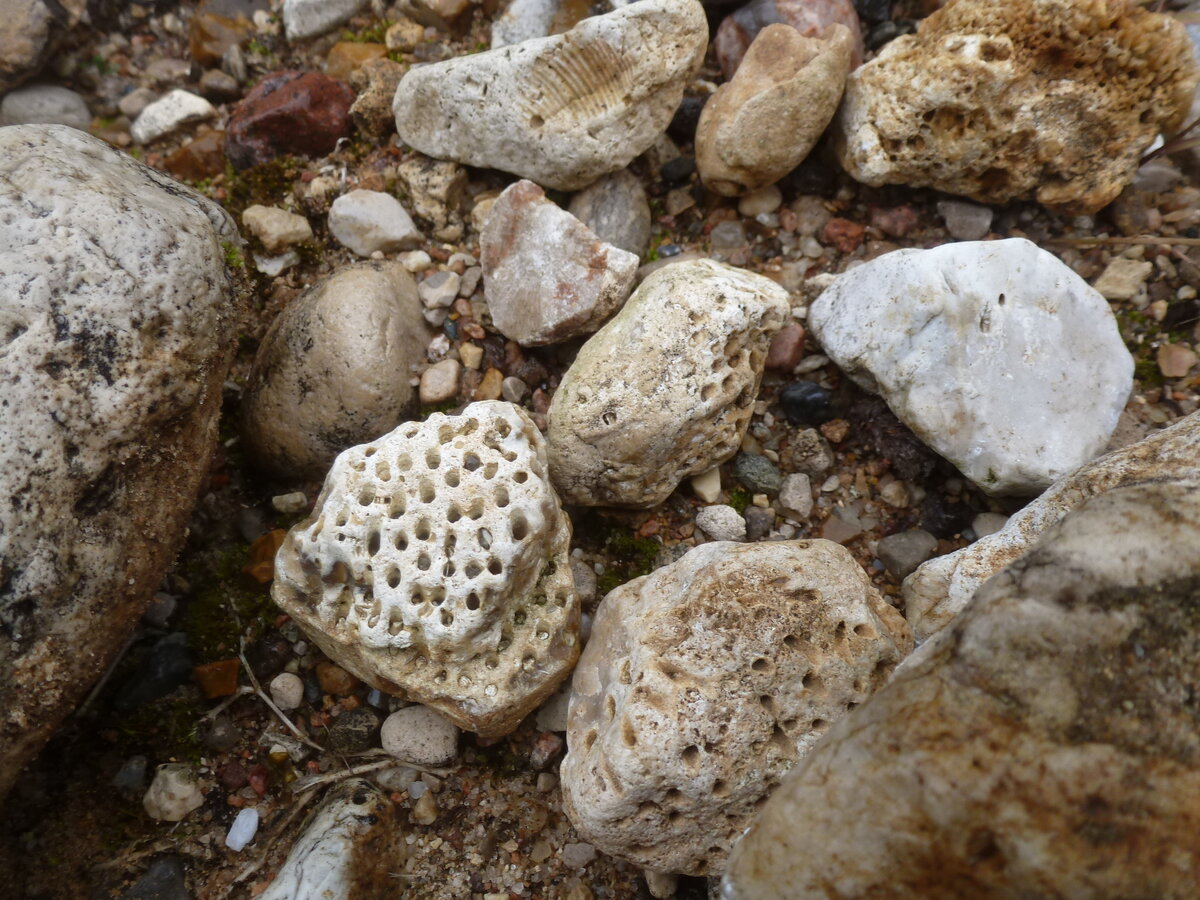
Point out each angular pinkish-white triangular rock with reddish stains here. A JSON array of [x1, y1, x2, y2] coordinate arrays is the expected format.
[[479, 180, 638, 347]]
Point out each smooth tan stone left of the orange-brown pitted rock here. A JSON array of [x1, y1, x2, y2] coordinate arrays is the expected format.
[[696, 22, 853, 197]]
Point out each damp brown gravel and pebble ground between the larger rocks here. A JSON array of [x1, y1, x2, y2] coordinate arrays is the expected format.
[[0, 0, 1200, 900]]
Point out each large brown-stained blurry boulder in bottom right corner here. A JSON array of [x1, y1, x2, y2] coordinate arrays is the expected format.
[[720, 481, 1200, 900]]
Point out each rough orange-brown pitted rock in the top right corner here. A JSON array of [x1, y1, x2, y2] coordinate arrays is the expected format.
[[835, 0, 1200, 214]]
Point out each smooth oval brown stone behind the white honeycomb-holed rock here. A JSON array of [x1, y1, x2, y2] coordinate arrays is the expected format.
[[241, 262, 431, 479]]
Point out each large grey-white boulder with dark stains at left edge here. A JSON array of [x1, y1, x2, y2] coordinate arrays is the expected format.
[[0, 125, 239, 796]]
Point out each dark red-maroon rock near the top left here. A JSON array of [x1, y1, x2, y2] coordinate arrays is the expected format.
[[226, 70, 354, 169]]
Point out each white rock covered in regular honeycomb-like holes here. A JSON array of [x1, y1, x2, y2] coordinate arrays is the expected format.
[[271, 401, 580, 737]]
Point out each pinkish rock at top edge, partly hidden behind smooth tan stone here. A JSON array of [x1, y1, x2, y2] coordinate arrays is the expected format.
[[713, 0, 863, 82]]
